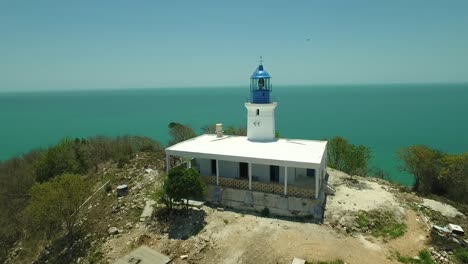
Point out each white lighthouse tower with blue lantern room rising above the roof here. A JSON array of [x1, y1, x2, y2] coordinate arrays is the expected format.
[[245, 58, 278, 142]]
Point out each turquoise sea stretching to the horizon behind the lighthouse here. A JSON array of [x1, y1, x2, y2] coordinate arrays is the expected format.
[[0, 84, 468, 185]]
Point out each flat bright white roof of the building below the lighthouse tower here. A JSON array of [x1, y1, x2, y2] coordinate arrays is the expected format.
[[166, 134, 327, 168]]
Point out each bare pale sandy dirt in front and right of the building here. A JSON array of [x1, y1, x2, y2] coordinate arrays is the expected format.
[[103, 170, 446, 264]]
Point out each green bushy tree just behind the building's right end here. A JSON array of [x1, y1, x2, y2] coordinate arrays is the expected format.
[[327, 137, 371, 175]]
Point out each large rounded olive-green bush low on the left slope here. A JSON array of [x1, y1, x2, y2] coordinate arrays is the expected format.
[[24, 174, 89, 238]]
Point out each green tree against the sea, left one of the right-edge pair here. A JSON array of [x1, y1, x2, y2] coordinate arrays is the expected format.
[[397, 145, 445, 194]]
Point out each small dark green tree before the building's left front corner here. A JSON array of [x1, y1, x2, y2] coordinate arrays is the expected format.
[[156, 167, 206, 209]]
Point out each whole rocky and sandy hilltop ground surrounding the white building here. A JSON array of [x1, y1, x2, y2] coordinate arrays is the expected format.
[[7, 153, 468, 263]]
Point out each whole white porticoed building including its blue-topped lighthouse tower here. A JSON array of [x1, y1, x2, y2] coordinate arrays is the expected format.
[[166, 64, 327, 219]]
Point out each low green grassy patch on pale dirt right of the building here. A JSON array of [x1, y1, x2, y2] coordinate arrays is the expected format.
[[356, 210, 406, 238]]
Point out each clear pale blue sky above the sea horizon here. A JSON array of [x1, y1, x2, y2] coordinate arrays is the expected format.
[[0, 0, 468, 91]]
